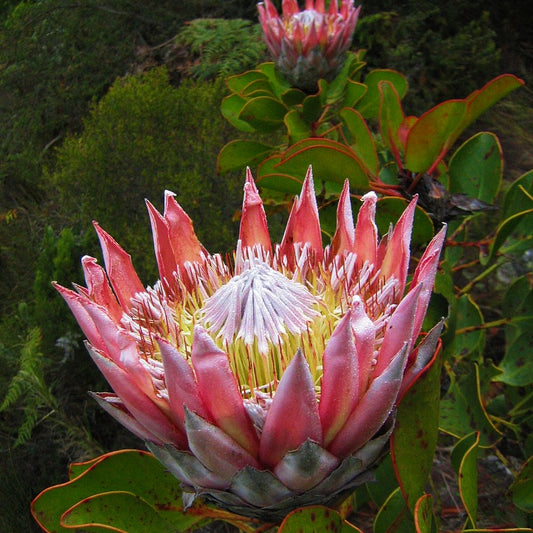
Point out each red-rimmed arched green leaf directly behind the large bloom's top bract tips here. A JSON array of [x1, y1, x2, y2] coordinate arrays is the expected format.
[[257, 138, 368, 194]]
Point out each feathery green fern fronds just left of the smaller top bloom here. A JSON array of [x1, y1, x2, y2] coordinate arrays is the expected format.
[[176, 19, 266, 80]]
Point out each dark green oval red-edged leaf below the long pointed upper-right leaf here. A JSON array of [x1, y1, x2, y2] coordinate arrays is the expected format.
[[448, 132, 503, 204]]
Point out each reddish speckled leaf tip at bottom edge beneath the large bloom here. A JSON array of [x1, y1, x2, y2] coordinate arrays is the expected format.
[[278, 505, 362, 533]]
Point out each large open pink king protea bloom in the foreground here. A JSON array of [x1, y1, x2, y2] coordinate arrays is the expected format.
[[57, 169, 444, 521]]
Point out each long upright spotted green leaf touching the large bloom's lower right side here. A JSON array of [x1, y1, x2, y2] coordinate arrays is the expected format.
[[390, 342, 442, 510]]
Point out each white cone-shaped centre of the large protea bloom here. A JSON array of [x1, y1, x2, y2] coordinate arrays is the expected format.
[[202, 262, 319, 354]]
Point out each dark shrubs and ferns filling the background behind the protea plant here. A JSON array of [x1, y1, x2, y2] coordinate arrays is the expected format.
[[0, 0, 533, 533]]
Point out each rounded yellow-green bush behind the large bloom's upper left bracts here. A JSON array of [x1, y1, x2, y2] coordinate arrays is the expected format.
[[50, 68, 243, 283]]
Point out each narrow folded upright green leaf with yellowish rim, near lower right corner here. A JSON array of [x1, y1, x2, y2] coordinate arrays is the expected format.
[[451, 432, 480, 527]]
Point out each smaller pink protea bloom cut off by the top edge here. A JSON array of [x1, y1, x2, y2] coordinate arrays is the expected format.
[[257, 0, 360, 92]]
